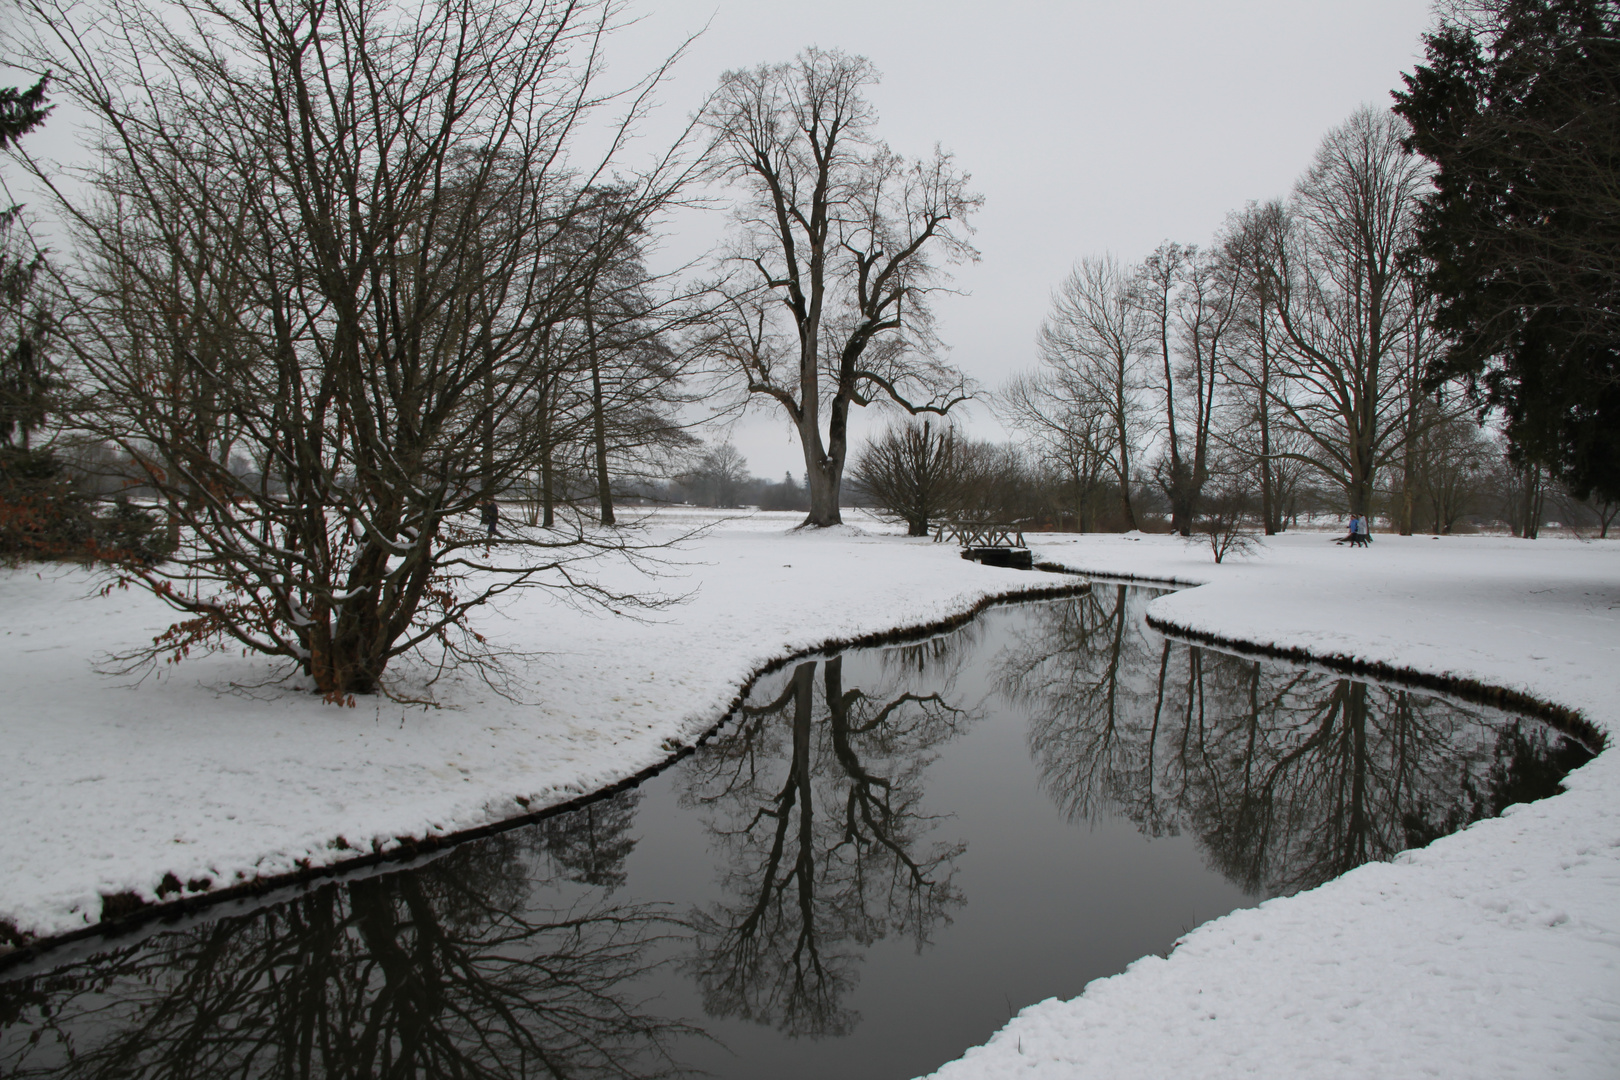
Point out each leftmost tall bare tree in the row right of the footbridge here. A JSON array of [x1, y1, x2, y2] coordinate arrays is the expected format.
[[1038, 256, 1150, 529]]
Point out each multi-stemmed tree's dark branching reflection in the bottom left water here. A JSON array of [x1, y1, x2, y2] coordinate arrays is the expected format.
[[0, 805, 692, 1080]]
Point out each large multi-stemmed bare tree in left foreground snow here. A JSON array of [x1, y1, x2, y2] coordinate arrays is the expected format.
[[11, 0, 696, 701]]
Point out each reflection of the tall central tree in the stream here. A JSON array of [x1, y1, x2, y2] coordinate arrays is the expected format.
[[682, 633, 975, 1036]]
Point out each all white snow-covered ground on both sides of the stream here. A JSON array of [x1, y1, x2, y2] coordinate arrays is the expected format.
[[0, 515, 1620, 1080]]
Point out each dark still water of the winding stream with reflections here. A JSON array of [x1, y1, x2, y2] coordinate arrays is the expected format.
[[0, 585, 1589, 1080]]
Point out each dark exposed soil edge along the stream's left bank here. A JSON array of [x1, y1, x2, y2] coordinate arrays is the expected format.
[[0, 572, 1090, 972]]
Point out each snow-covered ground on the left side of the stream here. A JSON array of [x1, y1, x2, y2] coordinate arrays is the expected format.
[[0, 510, 1074, 947]]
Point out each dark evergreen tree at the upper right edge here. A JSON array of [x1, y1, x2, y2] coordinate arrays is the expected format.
[[1395, 0, 1620, 497]]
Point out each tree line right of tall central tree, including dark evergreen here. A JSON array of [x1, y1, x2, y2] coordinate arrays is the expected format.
[[854, 0, 1620, 538]]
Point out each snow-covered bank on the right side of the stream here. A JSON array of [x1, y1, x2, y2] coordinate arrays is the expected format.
[[935, 534, 1620, 1080]]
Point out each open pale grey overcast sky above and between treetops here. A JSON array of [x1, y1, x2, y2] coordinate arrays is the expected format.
[[608, 0, 1430, 476]]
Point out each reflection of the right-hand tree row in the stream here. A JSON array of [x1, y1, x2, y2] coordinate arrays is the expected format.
[[1000, 585, 1591, 895]]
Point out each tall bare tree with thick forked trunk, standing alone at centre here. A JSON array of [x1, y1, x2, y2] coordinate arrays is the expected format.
[[703, 49, 980, 526]]
